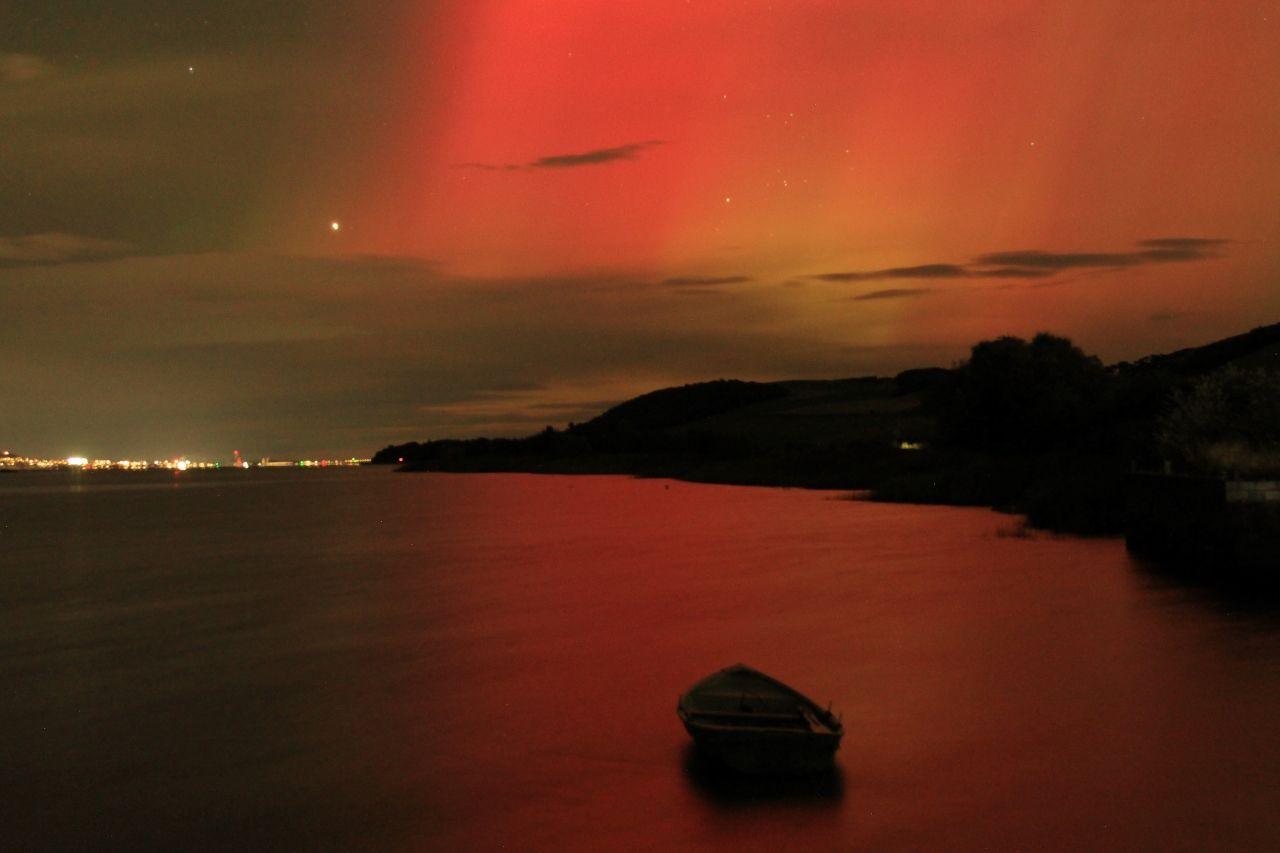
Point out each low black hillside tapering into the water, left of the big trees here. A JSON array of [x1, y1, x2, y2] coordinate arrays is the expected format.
[[374, 371, 931, 473]]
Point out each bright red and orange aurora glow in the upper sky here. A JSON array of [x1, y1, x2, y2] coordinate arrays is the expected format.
[[335, 0, 1280, 275]]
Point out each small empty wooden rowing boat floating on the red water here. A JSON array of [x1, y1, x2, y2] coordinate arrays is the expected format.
[[676, 663, 845, 774]]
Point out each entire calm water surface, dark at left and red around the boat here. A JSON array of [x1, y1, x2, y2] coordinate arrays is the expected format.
[[0, 470, 1280, 850]]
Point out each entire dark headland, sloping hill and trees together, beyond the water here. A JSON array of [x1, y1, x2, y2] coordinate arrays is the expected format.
[[374, 318, 1280, 533]]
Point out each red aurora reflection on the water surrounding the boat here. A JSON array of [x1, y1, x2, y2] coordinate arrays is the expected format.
[[381, 476, 1280, 849]]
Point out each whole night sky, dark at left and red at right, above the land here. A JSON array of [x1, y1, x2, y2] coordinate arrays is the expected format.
[[0, 0, 1280, 459]]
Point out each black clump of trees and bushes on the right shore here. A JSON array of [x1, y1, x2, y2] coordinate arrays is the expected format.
[[876, 327, 1280, 533]]
